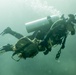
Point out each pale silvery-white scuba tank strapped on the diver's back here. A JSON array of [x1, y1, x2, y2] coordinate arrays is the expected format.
[[25, 15, 60, 33]]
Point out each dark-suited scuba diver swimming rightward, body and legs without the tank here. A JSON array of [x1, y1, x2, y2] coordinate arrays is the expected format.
[[1, 14, 76, 59]]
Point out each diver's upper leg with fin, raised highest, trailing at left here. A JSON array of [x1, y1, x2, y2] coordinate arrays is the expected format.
[[0, 27, 23, 39]]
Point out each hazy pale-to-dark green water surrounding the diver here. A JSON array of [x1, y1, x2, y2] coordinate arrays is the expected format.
[[0, 0, 76, 75]]
